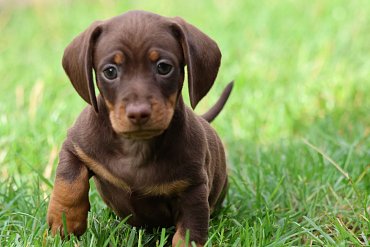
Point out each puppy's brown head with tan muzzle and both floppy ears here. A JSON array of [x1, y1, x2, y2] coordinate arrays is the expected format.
[[63, 11, 221, 139]]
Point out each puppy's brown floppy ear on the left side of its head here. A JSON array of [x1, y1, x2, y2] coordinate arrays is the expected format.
[[62, 22, 102, 112]]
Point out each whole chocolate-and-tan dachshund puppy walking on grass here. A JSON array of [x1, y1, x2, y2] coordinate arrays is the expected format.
[[47, 11, 233, 246]]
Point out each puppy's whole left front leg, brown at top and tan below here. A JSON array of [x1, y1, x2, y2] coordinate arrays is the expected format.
[[47, 144, 90, 237]]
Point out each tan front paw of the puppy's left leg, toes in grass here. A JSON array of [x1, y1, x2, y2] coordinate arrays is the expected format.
[[47, 198, 90, 238]]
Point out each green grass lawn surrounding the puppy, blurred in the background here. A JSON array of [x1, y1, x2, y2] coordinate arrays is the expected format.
[[0, 0, 370, 246]]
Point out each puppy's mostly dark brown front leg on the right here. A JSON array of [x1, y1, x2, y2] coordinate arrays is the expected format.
[[172, 184, 210, 247]]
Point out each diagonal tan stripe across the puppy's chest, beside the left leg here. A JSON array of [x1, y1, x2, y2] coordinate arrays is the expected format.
[[73, 144, 131, 193]]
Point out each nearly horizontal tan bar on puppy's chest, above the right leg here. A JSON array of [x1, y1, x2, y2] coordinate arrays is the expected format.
[[139, 180, 190, 196]]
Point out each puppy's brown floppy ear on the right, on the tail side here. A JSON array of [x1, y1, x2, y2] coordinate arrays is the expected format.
[[173, 17, 221, 109]]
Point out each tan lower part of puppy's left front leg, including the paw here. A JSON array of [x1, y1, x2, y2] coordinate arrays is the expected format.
[[47, 168, 90, 237]]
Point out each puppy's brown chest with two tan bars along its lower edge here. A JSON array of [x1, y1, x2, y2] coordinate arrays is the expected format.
[[75, 141, 190, 196]]
